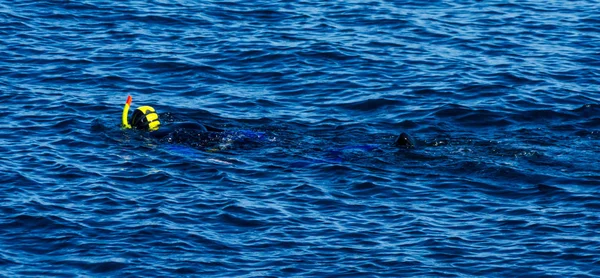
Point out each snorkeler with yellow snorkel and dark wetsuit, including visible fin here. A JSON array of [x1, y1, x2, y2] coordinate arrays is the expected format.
[[121, 96, 415, 151]]
